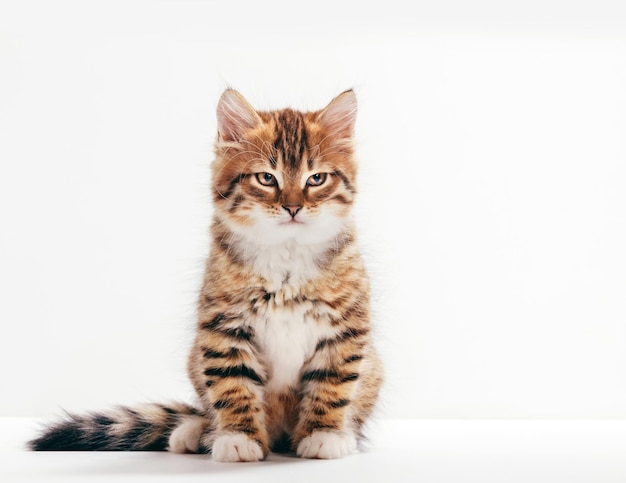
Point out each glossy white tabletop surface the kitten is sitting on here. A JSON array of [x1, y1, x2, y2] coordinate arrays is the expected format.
[[0, 419, 626, 483]]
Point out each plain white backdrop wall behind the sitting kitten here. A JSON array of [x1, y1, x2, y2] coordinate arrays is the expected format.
[[0, 0, 626, 418]]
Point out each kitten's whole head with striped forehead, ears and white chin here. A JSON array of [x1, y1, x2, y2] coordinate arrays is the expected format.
[[213, 90, 356, 244]]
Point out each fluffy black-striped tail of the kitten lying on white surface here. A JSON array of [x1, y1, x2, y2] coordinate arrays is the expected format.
[[28, 403, 204, 451]]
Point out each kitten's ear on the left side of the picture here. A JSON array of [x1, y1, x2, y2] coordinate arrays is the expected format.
[[217, 89, 262, 141]]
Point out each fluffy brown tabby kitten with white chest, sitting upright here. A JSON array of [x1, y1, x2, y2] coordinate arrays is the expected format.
[[30, 89, 382, 461]]
